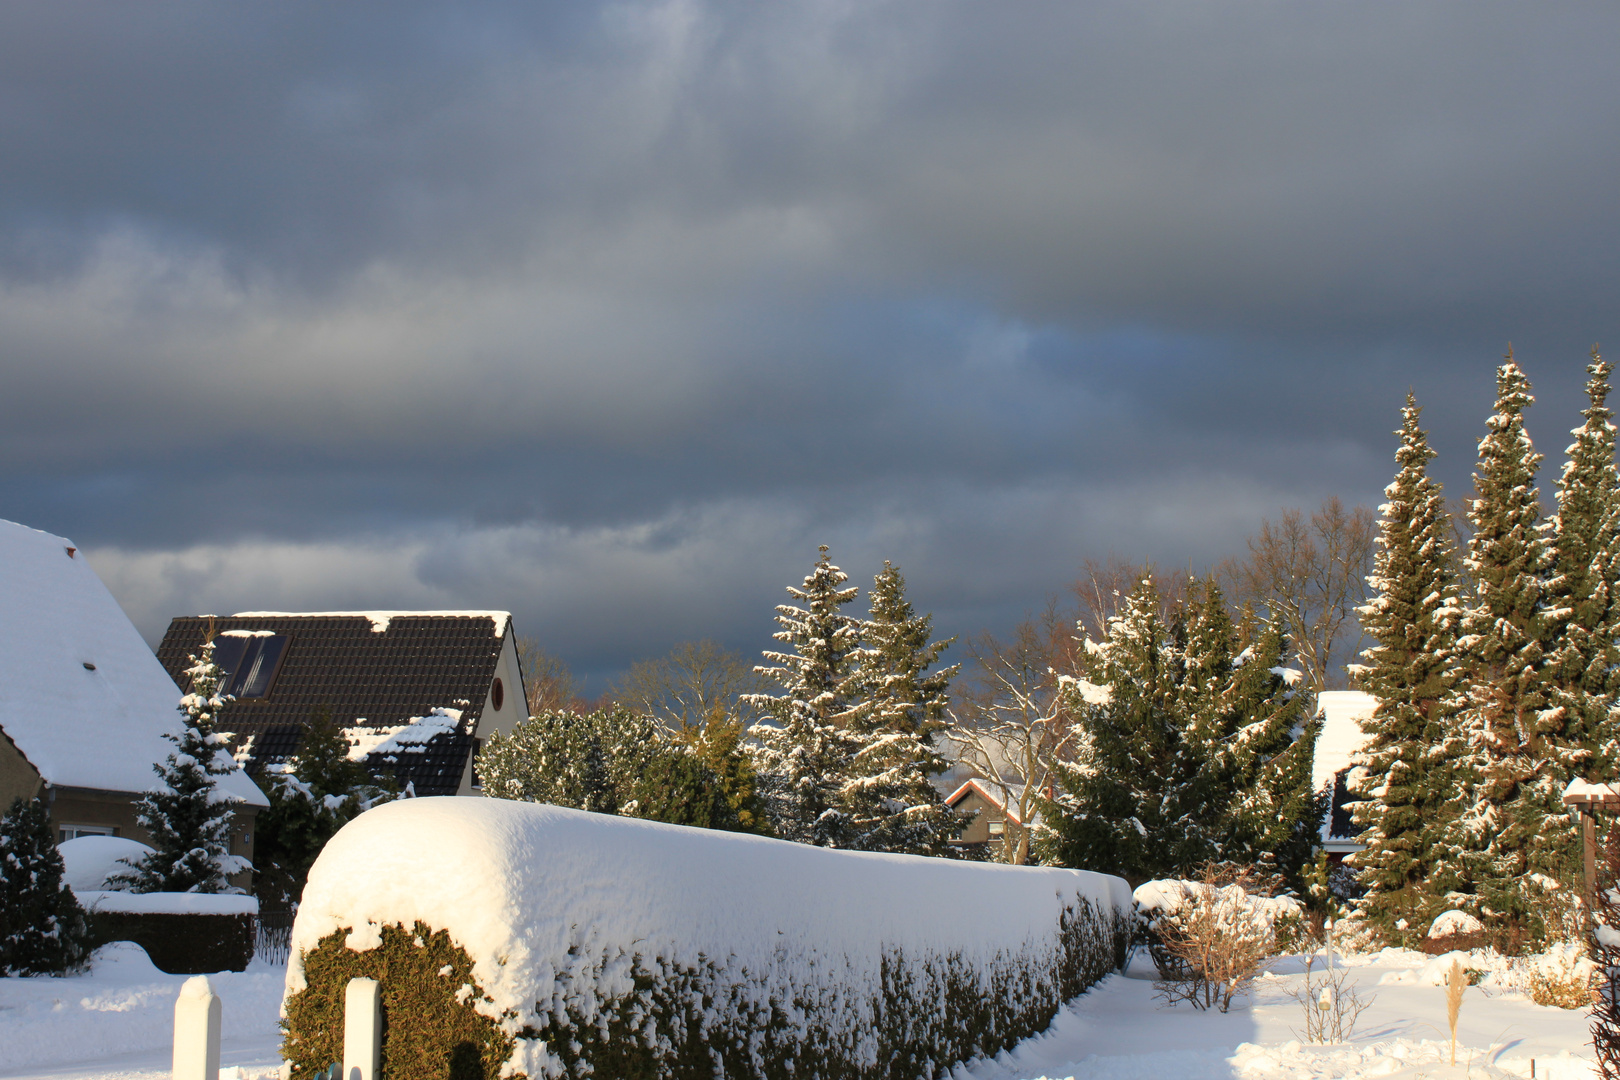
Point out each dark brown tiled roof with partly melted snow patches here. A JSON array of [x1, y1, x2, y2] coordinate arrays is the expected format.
[[157, 612, 509, 795]]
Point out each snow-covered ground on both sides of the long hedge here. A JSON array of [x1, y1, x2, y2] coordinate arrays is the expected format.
[[0, 944, 1596, 1080]]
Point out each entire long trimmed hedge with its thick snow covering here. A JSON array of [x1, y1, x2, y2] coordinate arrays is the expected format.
[[284, 798, 1131, 1080]]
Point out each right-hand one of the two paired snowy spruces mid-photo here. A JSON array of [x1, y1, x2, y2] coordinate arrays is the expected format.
[[846, 562, 962, 855]]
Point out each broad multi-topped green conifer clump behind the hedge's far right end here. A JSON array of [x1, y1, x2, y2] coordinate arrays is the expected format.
[[1038, 576, 1320, 881]]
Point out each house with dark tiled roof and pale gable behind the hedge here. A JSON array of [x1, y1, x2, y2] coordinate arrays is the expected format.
[[157, 610, 527, 795]]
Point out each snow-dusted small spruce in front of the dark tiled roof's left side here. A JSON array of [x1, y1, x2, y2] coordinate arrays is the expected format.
[[112, 636, 253, 892]]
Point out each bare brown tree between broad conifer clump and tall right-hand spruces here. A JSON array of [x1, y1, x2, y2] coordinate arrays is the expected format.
[[1221, 495, 1377, 691]]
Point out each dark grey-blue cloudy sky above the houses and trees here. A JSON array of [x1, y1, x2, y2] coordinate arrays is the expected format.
[[0, 0, 1620, 690]]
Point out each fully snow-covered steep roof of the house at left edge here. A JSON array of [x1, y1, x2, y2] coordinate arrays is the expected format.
[[0, 521, 269, 806]]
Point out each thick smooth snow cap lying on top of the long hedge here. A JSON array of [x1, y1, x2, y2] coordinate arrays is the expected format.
[[287, 797, 1131, 1014]]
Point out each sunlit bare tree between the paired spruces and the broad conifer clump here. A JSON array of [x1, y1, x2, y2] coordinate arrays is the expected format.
[[946, 606, 1076, 866]]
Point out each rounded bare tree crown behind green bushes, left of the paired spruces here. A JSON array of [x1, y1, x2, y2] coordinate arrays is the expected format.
[[612, 640, 771, 732]]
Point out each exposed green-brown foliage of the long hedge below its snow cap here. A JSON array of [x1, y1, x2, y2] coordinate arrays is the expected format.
[[282, 900, 1126, 1080]]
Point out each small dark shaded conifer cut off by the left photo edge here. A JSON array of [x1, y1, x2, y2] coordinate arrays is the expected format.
[[0, 798, 91, 976]]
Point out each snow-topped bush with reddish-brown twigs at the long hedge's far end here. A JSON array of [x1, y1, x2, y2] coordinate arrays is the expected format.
[[1134, 879, 1304, 1012]]
